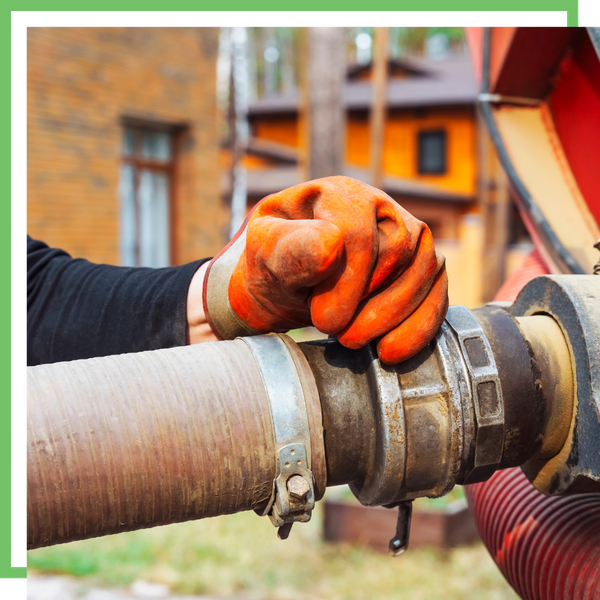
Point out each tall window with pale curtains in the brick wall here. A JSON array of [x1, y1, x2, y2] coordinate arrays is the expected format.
[[120, 127, 173, 267]]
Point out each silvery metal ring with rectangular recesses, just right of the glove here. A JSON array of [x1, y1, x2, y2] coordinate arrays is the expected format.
[[446, 306, 504, 471]]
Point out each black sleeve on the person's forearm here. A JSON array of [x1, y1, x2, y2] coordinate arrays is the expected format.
[[25, 235, 210, 366]]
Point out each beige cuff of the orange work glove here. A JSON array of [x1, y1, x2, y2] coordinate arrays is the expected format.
[[202, 227, 265, 340]]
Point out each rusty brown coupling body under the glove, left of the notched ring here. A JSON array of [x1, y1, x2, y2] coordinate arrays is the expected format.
[[299, 307, 476, 506]]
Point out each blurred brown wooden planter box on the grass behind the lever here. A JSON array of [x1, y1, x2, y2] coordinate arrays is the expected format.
[[323, 500, 479, 553]]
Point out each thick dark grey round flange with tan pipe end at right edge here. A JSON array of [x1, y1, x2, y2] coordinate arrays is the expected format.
[[511, 275, 600, 495]]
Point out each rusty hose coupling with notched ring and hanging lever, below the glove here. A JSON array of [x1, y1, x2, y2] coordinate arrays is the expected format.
[[300, 306, 510, 556]]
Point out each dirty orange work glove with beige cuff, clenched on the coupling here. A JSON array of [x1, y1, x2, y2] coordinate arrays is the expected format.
[[203, 177, 448, 364]]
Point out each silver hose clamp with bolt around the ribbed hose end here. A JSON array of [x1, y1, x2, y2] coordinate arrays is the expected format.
[[239, 334, 315, 539]]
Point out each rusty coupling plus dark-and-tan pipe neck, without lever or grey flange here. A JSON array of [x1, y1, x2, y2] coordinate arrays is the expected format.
[[299, 290, 600, 506]]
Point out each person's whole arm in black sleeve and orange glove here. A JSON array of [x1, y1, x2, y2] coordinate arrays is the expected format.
[[25, 177, 448, 365]]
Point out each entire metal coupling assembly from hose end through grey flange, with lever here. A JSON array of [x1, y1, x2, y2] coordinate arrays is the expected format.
[[299, 276, 600, 554]]
